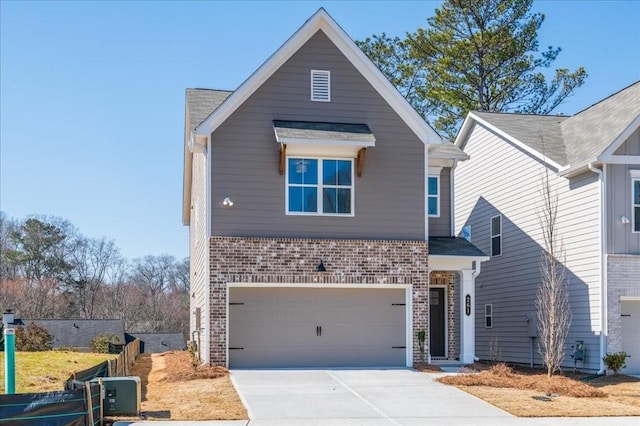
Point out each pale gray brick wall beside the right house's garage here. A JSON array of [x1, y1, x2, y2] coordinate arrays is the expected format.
[[607, 254, 640, 352]]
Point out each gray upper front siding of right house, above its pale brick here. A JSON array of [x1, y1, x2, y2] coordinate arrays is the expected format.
[[606, 129, 640, 254]]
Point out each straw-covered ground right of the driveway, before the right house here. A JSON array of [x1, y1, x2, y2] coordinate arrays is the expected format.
[[438, 364, 640, 417]]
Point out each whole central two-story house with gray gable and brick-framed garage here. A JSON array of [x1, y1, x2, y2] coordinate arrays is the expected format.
[[183, 9, 487, 367]]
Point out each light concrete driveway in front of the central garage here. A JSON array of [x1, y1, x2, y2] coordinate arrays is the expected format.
[[232, 369, 514, 426]]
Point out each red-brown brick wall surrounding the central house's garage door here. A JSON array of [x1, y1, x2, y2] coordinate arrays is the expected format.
[[209, 237, 429, 365]]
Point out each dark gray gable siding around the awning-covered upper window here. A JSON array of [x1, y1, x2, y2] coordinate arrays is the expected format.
[[211, 32, 425, 239]]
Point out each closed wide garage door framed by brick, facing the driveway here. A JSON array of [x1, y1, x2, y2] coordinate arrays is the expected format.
[[229, 287, 406, 368]]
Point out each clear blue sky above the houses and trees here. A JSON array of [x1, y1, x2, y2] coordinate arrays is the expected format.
[[0, 0, 640, 258]]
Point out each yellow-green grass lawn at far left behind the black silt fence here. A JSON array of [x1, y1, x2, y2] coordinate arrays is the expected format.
[[0, 351, 117, 394]]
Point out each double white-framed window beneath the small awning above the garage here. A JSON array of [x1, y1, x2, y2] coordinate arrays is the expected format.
[[286, 158, 353, 216]]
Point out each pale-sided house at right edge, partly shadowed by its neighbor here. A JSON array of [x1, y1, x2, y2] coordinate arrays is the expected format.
[[455, 82, 640, 374]]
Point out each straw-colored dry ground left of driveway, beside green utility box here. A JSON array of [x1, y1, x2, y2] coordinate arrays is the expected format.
[[106, 351, 248, 420]]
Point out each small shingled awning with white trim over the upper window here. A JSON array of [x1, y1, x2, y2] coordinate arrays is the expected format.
[[273, 120, 376, 158]]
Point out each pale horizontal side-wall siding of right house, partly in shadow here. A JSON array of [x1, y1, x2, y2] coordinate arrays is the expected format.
[[455, 122, 600, 369]]
